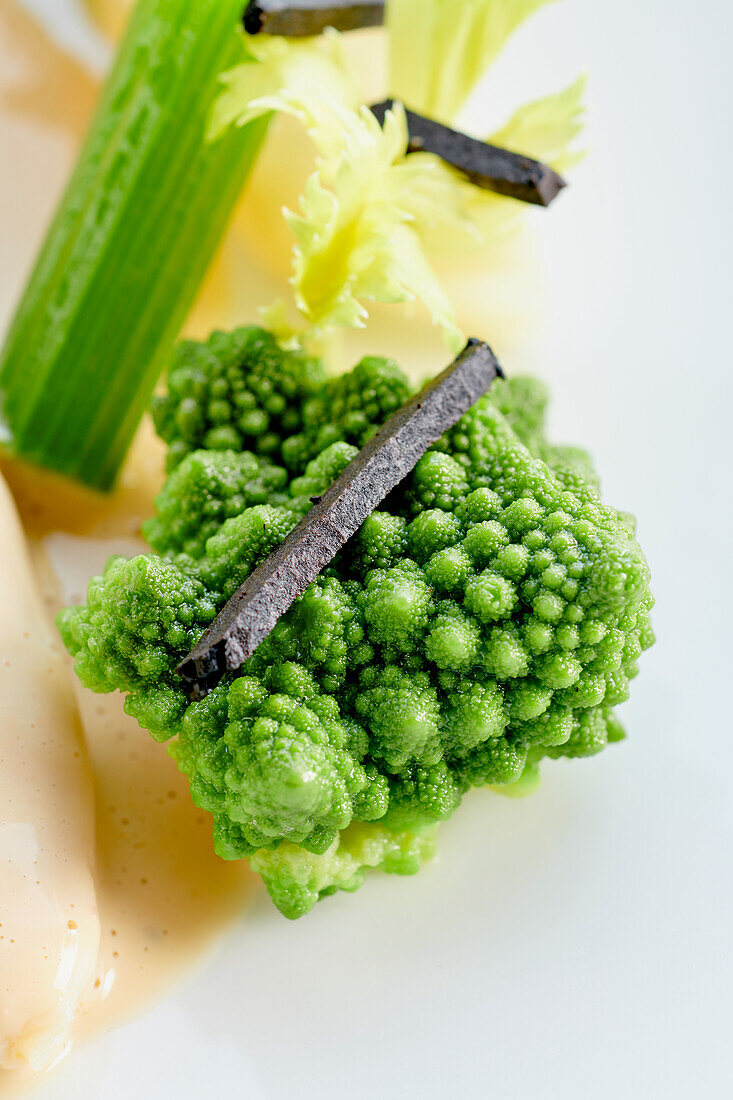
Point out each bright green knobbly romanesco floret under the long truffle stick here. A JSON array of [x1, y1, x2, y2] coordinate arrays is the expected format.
[[59, 330, 654, 916]]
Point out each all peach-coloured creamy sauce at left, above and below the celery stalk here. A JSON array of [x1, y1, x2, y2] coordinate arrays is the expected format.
[[0, 0, 254, 1092]]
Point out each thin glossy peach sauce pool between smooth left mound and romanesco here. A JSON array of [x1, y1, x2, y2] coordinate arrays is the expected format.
[[17, 422, 254, 1033]]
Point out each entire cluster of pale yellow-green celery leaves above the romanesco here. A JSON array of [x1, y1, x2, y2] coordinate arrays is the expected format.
[[205, 11, 582, 350]]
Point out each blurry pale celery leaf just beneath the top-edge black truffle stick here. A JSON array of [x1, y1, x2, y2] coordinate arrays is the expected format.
[[208, 31, 360, 141]]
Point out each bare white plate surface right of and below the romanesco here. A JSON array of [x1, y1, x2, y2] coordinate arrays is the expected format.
[[12, 0, 733, 1100]]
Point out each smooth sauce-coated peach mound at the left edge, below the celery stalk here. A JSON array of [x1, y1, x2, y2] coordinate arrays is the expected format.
[[0, 475, 100, 1071]]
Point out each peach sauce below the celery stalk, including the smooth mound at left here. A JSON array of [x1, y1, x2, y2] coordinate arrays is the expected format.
[[0, 430, 254, 1086]]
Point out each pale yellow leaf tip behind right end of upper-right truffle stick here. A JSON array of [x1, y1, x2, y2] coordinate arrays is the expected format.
[[489, 76, 587, 172]]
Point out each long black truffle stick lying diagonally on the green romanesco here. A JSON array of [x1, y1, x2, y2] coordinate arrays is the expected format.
[[178, 340, 503, 699]]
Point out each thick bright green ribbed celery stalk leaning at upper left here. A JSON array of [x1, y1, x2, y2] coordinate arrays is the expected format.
[[0, 0, 266, 488]]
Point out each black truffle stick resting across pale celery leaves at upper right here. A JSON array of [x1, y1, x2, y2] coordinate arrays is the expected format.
[[371, 99, 567, 207]]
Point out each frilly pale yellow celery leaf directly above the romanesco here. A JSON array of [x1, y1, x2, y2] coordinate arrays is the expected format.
[[253, 94, 468, 350]]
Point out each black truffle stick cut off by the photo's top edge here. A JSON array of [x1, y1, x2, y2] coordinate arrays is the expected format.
[[243, 0, 384, 39]]
